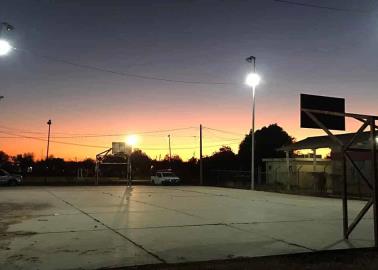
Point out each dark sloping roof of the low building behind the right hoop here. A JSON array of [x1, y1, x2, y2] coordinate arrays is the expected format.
[[278, 132, 370, 151]]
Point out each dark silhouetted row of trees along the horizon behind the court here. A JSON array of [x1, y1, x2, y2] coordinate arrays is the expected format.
[[0, 124, 294, 183]]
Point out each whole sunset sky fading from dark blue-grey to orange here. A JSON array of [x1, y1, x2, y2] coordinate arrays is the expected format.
[[0, 0, 378, 160]]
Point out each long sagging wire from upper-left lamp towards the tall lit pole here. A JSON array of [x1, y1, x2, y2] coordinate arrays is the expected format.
[[14, 48, 238, 85]]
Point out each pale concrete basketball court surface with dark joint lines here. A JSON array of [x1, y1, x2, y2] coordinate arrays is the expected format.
[[0, 186, 373, 270]]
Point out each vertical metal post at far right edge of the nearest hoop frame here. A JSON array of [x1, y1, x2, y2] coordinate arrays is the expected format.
[[370, 117, 378, 247]]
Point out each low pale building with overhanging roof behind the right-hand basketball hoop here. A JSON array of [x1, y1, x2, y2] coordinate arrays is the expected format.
[[262, 132, 371, 195]]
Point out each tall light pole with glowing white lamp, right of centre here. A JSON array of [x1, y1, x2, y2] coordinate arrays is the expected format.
[[245, 56, 260, 190]]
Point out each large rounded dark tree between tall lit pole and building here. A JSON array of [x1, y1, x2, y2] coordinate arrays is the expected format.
[[238, 124, 294, 173]]
